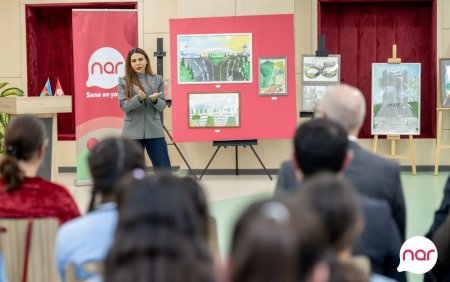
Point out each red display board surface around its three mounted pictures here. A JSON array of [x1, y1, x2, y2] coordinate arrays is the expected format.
[[170, 14, 297, 142]]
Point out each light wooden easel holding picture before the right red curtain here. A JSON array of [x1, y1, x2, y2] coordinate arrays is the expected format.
[[372, 44, 416, 175]]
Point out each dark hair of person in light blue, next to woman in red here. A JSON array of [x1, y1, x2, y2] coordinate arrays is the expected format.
[[88, 137, 145, 211]]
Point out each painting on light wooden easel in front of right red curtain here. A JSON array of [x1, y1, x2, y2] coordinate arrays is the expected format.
[[371, 63, 421, 135]]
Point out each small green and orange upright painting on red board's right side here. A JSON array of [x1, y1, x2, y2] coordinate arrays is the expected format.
[[259, 57, 287, 96]]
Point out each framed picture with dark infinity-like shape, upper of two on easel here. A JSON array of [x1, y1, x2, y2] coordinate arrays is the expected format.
[[302, 55, 341, 84]]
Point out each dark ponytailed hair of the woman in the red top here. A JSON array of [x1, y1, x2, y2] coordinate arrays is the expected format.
[[0, 115, 46, 192]]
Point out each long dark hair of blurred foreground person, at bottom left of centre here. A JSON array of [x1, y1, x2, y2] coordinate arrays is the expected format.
[[104, 174, 214, 282]]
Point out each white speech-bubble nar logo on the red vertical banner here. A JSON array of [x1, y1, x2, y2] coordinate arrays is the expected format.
[[86, 47, 125, 89]]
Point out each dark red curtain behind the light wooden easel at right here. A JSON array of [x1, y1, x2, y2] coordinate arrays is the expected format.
[[318, 0, 436, 138]]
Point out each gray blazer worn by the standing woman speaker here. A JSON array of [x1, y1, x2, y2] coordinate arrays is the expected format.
[[118, 75, 166, 139]]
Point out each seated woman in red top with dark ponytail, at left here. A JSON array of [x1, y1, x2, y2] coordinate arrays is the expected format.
[[0, 115, 80, 223]]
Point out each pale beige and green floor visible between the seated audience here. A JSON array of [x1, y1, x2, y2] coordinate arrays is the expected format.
[[59, 172, 448, 281]]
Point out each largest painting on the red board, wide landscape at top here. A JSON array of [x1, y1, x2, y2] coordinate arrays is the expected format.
[[177, 33, 252, 84]]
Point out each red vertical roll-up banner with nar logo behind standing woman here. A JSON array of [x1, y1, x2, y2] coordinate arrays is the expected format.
[[72, 10, 138, 181]]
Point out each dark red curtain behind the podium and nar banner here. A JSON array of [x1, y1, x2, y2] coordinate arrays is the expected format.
[[25, 2, 136, 140]]
